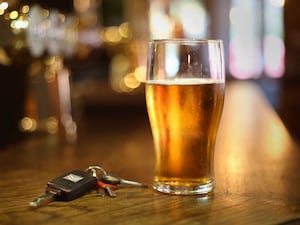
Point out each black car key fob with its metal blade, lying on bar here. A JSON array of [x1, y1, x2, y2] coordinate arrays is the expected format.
[[29, 170, 98, 209]]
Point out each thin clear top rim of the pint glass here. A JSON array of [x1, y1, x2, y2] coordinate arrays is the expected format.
[[149, 38, 223, 44]]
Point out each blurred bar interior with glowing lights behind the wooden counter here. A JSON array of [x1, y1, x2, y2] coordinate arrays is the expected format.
[[0, 0, 300, 146]]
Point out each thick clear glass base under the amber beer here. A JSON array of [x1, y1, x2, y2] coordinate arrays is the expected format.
[[153, 181, 215, 195]]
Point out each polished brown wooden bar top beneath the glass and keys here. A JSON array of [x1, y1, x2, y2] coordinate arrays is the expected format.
[[0, 82, 300, 225]]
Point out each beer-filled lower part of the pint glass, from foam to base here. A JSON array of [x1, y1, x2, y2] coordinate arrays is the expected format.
[[146, 78, 225, 194]]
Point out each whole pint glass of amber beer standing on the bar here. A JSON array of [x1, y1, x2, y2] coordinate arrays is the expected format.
[[145, 39, 225, 195]]
